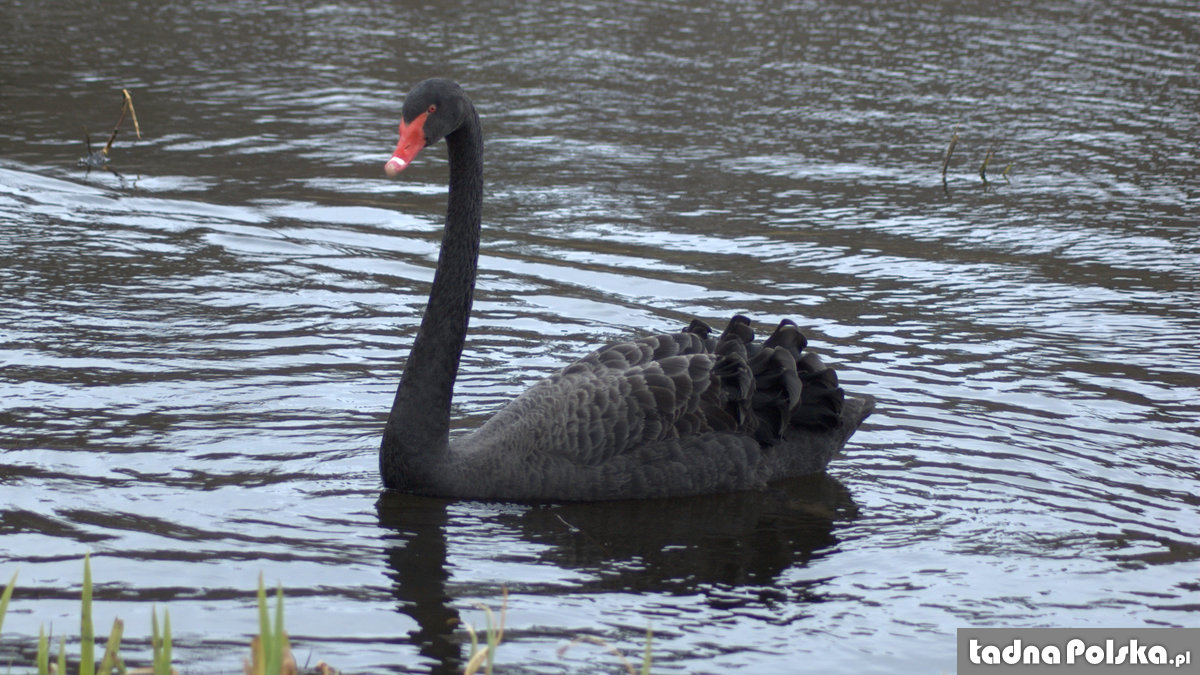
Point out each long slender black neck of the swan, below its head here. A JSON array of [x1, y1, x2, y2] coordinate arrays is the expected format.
[[379, 104, 484, 489]]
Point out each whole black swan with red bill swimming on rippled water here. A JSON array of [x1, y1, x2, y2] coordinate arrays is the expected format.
[[379, 79, 875, 501]]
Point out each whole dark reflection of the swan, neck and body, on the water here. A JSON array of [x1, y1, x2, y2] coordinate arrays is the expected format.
[[376, 474, 858, 675]]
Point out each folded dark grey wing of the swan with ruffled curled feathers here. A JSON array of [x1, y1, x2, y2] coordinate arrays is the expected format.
[[468, 315, 842, 465]]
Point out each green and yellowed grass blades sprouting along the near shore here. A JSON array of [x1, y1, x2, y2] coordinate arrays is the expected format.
[[0, 554, 653, 675]]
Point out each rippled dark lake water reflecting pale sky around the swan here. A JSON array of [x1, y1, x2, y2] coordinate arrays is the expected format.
[[0, 0, 1200, 674]]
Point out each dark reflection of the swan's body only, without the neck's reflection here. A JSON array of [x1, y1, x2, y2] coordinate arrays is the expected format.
[[492, 473, 858, 588]]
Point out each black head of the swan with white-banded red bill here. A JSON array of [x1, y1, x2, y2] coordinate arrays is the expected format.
[[383, 78, 469, 177]]
